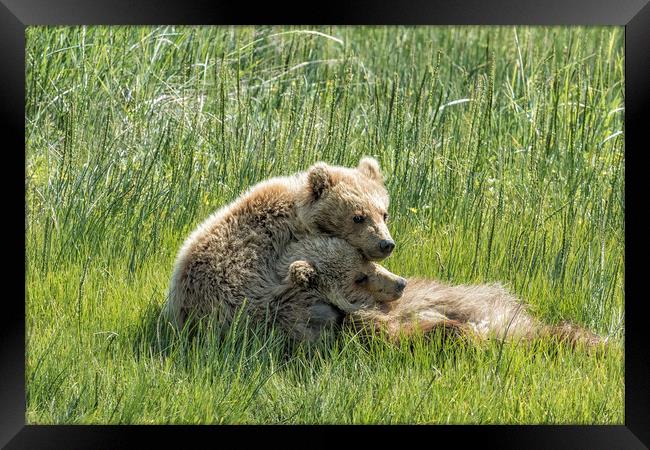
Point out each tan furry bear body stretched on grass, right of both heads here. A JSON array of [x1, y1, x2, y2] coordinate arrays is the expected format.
[[346, 278, 606, 347]]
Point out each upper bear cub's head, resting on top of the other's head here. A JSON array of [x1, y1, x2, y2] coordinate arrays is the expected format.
[[303, 157, 395, 261]]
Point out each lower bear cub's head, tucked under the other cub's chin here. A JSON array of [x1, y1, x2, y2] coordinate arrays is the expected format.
[[286, 238, 406, 313]]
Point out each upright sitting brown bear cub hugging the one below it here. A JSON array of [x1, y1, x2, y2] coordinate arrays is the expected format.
[[164, 158, 395, 328]]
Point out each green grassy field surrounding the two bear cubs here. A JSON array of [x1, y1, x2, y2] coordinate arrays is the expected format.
[[25, 27, 625, 424]]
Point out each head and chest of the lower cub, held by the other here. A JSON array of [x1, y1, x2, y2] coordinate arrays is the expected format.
[[264, 235, 406, 342]]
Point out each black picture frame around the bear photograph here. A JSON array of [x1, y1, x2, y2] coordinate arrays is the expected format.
[[6, 0, 650, 449]]
